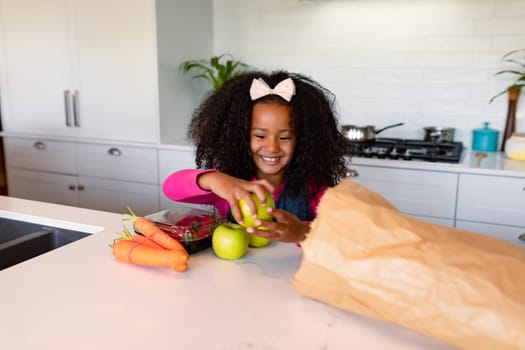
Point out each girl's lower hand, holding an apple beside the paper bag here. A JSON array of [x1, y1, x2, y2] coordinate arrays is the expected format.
[[246, 208, 310, 242]]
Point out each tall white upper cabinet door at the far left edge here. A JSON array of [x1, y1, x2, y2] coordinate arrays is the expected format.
[[0, 0, 73, 134]]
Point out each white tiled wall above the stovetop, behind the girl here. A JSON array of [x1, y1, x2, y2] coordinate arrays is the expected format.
[[214, 0, 525, 146]]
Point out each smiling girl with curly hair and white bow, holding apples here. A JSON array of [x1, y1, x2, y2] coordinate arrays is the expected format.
[[163, 71, 345, 242]]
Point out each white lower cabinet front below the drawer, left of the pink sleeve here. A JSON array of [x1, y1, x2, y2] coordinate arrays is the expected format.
[[78, 176, 159, 216]]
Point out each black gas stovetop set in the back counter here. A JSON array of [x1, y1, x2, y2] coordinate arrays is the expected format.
[[346, 138, 463, 163]]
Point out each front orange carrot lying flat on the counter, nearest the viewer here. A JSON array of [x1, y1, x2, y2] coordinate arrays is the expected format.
[[113, 239, 188, 272]]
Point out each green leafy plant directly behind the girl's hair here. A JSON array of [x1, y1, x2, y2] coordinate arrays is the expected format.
[[179, 54, 249, 90]]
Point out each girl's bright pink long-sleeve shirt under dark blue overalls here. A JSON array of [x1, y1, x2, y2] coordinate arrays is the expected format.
[[162, 169, 328, 218]]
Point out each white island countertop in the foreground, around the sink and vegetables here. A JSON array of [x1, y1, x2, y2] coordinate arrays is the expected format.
[[0, 197, 450, 350]]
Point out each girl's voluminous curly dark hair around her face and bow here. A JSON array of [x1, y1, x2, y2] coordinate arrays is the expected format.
[[188, 71, 345, 197]]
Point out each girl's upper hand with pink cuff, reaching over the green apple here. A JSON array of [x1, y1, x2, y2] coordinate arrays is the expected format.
[[197, 171, 275, 223]]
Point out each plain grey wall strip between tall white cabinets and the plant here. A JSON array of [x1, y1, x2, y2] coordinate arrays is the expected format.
[[156, 0, 213, 144]]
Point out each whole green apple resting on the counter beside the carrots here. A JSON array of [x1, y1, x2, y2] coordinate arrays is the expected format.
[[211, 223, 250, 260]]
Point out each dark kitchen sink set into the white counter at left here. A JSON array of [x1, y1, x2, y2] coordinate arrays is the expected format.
[[0, 218, 90, 270]]
